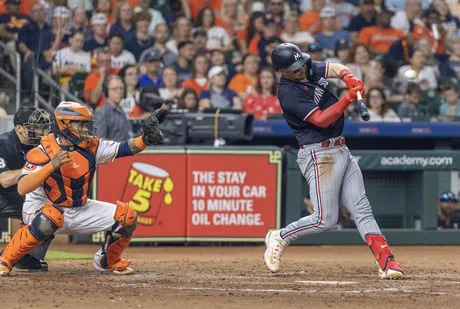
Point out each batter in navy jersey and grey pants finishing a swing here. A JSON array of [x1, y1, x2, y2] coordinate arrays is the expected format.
[[264, 43, 404, 279]]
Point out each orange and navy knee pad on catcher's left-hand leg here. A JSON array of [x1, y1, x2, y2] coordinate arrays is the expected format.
[[29, 204, 64, 241]]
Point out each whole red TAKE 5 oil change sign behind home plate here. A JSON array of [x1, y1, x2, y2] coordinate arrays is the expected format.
[[93, 149, 282, 242]]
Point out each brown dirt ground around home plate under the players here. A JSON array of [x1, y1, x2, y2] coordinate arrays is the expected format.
[[0, 244, 460, 309]]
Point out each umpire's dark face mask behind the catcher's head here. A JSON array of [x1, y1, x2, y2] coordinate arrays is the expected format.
[[14, 106, 51, 146]]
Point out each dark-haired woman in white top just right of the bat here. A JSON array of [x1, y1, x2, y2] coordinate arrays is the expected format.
[[366, 88, 401, 122]]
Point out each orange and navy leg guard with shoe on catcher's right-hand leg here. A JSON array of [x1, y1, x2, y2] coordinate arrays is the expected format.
[[94, 201, 137, 274]]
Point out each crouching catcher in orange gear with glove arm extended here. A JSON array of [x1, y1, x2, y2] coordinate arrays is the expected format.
[[0, 102, 167, 276]]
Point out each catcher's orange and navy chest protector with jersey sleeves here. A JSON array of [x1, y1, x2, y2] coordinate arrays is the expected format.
[[19, 134, 119, 207]]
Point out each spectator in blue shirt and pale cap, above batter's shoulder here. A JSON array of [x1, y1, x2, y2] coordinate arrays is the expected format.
[[315, 7, 351, 55]]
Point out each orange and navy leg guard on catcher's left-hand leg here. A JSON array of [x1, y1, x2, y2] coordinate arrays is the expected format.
[[0, 204, 64, 275]]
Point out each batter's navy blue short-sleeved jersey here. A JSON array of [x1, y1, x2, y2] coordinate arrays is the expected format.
[[278, 62, 344, 145]]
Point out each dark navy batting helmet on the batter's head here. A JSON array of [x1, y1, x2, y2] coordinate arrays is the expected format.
[[272, 43, 311, 72]]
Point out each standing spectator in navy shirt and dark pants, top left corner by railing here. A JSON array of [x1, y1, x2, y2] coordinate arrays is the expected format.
[[17, 3, 65, 97]]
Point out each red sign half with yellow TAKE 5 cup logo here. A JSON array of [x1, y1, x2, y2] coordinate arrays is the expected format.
[[95, 149, 187, 241]]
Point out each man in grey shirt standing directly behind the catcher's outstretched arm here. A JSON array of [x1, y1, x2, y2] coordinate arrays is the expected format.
[[94, 75, 133, 142]]
